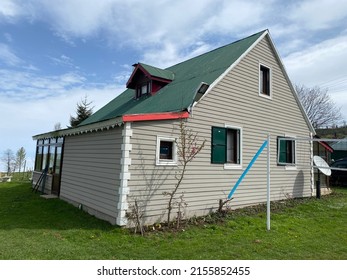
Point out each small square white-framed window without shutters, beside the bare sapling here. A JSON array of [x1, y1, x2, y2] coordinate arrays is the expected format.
[[155, 136, 177, 165]]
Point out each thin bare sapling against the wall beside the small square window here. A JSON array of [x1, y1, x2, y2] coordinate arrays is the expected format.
[[163, 119, 206, 226]]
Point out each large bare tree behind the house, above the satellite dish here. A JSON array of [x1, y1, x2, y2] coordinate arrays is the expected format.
[[295, 85, 342, 128]]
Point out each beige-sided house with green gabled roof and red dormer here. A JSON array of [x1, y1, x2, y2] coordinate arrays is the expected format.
[[33, 30, 315, 226]]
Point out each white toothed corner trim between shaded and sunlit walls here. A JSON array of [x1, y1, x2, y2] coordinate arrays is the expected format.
[[116, 122, 133, 226]]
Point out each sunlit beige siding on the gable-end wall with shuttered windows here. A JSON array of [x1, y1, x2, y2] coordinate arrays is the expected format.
[[128, 37, 311, 223]]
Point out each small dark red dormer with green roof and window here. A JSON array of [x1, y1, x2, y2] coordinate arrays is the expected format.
[[126, 63, 174, 99]]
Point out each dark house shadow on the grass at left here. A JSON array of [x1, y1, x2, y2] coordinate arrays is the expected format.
[[0, 182, 120, 231]]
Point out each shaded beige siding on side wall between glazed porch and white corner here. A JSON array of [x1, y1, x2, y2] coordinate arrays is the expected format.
[[60, 127, 122, 224]]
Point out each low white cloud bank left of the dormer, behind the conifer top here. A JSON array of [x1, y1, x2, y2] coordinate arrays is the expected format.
[[0, 70, 124, 171]]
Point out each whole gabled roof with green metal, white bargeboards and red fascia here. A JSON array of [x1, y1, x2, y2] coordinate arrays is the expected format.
[[33, 30, 315, 139]]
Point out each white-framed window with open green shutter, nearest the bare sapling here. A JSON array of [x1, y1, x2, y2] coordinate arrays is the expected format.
[[211, 125, 242, 169]]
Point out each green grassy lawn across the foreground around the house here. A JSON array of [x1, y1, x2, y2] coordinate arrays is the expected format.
[[0, 182, 347, 260]]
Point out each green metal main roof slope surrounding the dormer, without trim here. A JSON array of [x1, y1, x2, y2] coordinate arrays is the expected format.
[[80, 31, 266, 126]]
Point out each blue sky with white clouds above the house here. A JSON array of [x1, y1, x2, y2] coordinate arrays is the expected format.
[[0, 0, 347, 171]]
